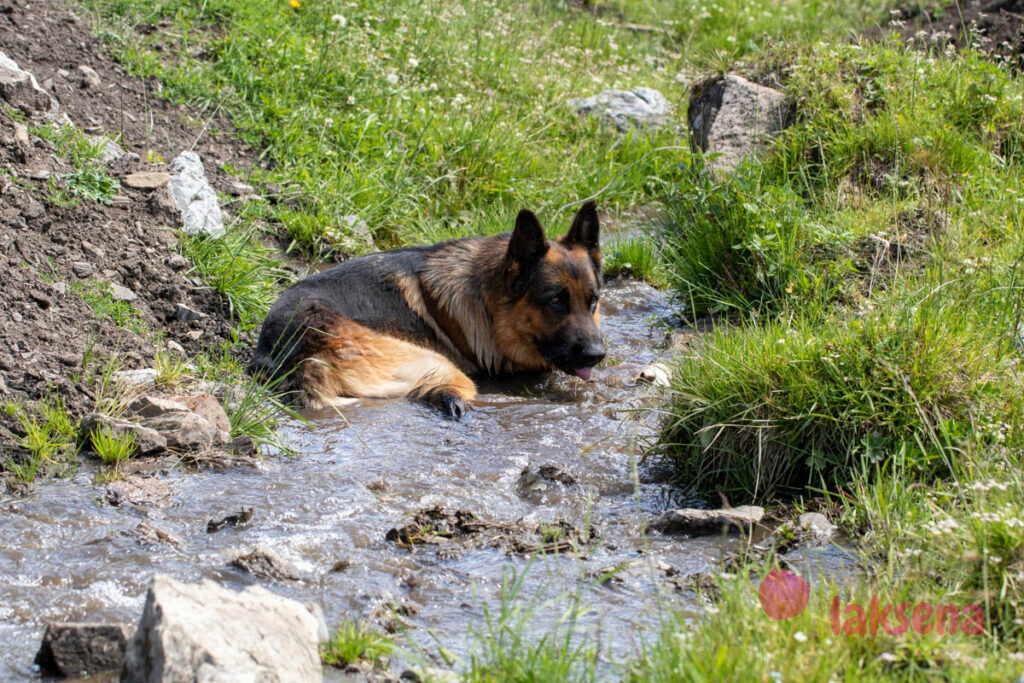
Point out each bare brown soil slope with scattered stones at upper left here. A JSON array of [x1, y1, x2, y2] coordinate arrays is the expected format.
[[0, 0, 254, 430]]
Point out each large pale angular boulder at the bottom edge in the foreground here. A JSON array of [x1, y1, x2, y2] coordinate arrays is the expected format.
[[121, 574, 327, 683]]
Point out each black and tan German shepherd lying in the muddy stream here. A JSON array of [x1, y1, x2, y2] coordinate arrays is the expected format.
[[251, 202, 604, 419]]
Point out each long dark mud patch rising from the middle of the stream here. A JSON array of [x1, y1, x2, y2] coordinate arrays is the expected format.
[[384, 506, 597, 558]]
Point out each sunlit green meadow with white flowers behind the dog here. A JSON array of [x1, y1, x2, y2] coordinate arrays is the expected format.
[[77, 0, 883, 255]]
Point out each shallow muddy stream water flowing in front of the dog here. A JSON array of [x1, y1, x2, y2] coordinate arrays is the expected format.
[[0, 281, 753, 680]]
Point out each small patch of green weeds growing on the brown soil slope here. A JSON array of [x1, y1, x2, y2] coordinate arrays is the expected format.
[[34, 124, 121, 206]]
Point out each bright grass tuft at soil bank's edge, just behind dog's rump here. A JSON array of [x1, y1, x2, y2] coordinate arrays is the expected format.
[[180, 229, 290, 329]]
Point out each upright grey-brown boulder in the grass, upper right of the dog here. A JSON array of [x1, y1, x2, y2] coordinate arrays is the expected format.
[[686, 76, 792, 172]]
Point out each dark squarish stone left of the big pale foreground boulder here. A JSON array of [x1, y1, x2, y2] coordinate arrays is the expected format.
[[36, 624, 131, 678]]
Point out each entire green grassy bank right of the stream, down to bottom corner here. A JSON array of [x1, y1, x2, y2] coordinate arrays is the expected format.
[[647, 36, 1024, 681]]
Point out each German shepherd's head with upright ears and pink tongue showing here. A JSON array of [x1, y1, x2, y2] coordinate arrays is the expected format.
[[504, 202, 604, 380]]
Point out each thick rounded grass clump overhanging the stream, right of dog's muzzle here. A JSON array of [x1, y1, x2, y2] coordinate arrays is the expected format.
[[662, 284, 1017, 500]]
